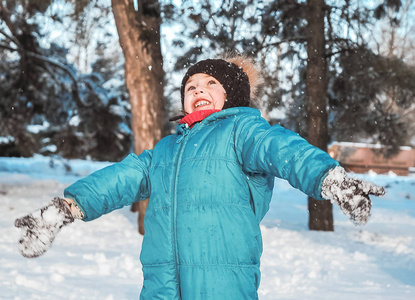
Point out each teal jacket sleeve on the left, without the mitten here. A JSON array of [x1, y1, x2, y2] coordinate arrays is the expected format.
[[64, 150, 153, 221]]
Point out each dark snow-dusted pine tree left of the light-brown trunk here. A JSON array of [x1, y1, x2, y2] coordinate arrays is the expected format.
[[0, 1, 132, 160]]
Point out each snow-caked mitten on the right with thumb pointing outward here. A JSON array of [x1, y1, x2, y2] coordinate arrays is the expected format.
[[321, 167, 385, 225]]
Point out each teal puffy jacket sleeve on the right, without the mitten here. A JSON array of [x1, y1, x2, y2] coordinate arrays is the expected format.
[[235, 116, 339, 200]]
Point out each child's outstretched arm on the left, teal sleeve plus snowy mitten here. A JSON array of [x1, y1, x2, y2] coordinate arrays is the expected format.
[[15, 151, 152, 258]]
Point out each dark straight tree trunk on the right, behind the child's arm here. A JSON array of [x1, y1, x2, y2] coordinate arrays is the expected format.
[[306, 0, 334, 231]]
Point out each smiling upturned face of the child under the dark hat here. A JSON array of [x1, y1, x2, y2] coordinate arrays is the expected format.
[[184, 73, 226, 114]]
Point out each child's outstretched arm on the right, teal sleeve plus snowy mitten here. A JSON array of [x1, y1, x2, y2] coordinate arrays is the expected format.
[[235, 117, 385, 225]]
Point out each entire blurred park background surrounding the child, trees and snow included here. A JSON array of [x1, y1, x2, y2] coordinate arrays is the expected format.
[[0, 0, 415, 300]]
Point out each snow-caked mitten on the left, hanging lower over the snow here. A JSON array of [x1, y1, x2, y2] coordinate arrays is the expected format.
[[14, 197, 74, 258]]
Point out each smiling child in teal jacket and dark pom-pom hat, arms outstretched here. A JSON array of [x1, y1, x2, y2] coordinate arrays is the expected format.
[[15, 57, 384, 300]]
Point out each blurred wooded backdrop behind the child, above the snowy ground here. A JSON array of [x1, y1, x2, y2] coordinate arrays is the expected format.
[[0, 0, 415, 166]]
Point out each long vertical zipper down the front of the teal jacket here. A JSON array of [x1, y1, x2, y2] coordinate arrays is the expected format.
[[172, 125, 190, 299]]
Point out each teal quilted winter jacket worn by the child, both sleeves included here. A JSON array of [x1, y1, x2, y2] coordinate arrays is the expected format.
[[65, 107, 338, 300]]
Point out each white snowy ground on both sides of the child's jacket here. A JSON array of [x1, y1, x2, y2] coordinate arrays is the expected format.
[[0, 157, 415, 300]]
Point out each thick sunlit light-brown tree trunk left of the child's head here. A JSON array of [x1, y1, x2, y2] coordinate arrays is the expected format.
[[111, 0, 165, 234]]
